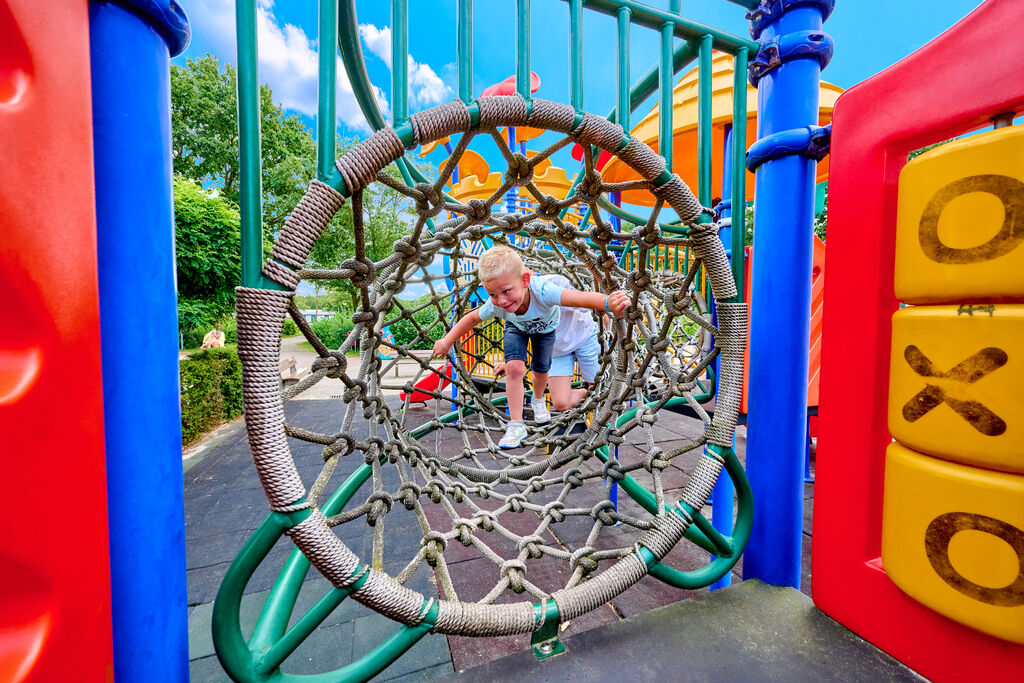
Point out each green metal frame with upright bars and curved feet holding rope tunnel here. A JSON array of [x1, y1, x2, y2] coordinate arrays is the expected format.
[[222, 0, 758, 683]]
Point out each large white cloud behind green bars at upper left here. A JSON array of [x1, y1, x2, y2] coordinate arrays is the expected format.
[[178, 0, 390, 132]]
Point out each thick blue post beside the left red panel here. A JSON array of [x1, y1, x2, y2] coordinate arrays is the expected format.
[[89, 0, 189, 681]]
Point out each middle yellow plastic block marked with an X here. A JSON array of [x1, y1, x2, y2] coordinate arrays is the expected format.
[[889, 304, 1024, 472]]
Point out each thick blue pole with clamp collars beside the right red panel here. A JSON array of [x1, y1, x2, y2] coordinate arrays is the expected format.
[[743, 4, 822, 588]]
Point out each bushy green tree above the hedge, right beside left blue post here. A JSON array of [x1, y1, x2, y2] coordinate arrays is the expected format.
[[174, 175, 242, 330]]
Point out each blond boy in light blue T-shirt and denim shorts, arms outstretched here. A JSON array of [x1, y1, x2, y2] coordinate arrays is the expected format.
[[433, 245, 630, 449]]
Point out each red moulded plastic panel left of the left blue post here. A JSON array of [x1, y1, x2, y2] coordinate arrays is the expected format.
[[0, 0, 113, 682]]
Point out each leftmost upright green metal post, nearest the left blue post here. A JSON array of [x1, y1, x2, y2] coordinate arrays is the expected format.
[[234, 0, 263, 287]]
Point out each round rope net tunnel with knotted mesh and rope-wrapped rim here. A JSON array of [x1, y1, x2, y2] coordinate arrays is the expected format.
[[238, 96, 745, 636]]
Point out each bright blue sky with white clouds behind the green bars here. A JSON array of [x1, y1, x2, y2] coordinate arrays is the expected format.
[[173, 0, 980, 296]]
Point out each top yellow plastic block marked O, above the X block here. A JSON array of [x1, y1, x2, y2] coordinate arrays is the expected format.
[[894, 126, 1024, 303]]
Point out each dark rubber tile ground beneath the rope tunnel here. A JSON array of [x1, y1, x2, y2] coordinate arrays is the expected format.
[[184, 393, 813, 683]]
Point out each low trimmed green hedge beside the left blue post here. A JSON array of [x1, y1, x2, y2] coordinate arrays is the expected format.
[[180, 348, 242, 445]]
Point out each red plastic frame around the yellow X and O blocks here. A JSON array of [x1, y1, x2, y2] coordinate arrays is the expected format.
[[812, 0, 1024, 681]]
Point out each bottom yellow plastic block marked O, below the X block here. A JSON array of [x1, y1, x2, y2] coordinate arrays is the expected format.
[[882, 443, 1024, 643]]
